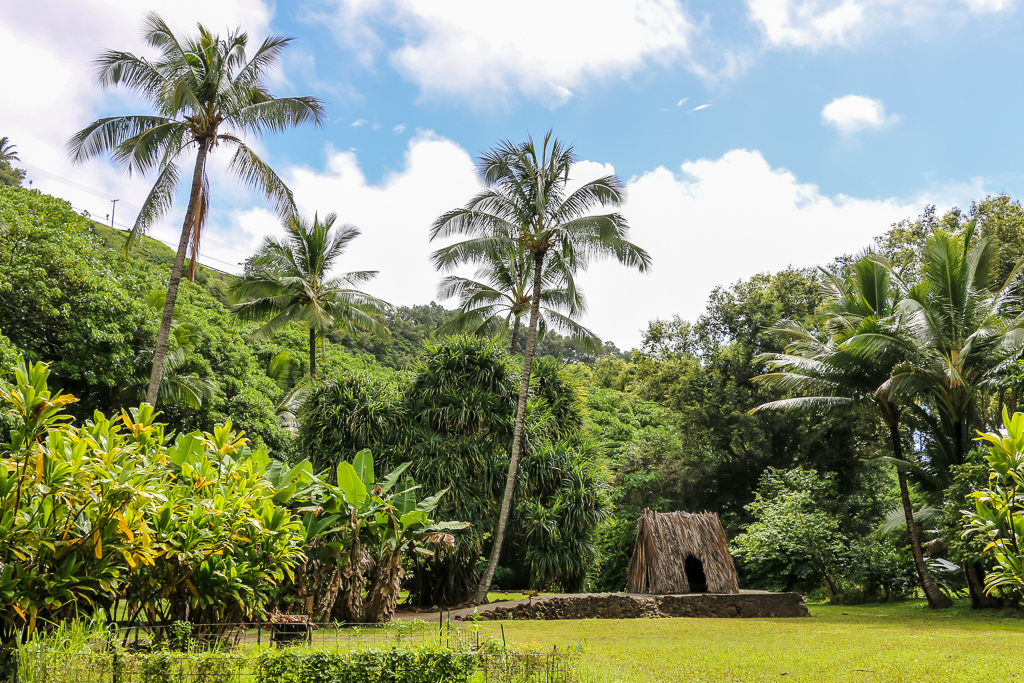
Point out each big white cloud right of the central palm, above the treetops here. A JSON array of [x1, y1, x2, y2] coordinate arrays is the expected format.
[[580, 150, 984, 347]]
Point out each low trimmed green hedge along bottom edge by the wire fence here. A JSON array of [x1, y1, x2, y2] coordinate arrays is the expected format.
[[256, 647, 476, 683]]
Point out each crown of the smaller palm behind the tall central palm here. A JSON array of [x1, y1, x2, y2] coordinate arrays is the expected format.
[[437, 245, 601, 354]]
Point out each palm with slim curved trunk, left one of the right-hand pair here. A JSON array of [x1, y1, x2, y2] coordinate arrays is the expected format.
[[751, 255, 952, 608]]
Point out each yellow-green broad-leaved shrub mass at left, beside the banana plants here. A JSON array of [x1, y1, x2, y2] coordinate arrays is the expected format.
[[0, 361, 302, 644]]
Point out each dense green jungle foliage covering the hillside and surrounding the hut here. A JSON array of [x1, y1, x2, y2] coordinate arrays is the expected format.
[[0, 187, 1024, 618]]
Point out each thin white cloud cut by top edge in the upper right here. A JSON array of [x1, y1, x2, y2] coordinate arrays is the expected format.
[[746, 0, 1017, 49]]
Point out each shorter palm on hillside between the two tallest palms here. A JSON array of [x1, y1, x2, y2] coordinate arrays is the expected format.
[[230, 213, 388, 379]]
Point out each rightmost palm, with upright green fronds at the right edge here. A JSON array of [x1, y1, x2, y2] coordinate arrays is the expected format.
[[849, 223, 1024, 606]]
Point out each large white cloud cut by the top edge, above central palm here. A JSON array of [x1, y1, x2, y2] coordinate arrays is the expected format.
[[312, 0, 695, 106]]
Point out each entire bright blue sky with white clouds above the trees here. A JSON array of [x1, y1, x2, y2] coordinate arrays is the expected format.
[[0, 0, 1024, 347]]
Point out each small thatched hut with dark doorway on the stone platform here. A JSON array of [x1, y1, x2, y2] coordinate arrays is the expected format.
[[626, 509, 739, 595]]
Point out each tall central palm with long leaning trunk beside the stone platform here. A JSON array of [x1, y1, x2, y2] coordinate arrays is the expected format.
[[430, 131, 650, 603]]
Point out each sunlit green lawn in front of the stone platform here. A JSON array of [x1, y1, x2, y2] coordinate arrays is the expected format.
[[480, 602, 1024, 683]]
